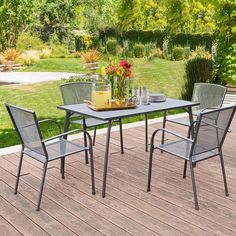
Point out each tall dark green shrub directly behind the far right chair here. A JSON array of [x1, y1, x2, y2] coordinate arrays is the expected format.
[[181, 57, 213, 101]]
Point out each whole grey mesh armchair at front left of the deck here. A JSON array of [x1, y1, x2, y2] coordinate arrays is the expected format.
[[6, 104, 95, 211]]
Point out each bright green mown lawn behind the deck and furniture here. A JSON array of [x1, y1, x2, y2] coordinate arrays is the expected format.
[[0, 58, 184, 148]]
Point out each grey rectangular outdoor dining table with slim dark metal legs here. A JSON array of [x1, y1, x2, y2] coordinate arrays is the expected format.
[[58, 98, 199, 197]]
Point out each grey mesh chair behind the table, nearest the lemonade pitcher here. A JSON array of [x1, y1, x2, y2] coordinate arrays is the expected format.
[[60, 82, 124, 163]]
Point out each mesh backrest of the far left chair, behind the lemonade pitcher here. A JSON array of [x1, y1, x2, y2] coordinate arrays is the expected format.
[[60, 82, 93, 105]]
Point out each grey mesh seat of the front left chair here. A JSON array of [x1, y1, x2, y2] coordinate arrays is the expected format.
[[24, 139, 88, 163]]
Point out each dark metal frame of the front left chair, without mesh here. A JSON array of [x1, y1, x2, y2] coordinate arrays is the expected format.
[[5, 104, 95, 211]]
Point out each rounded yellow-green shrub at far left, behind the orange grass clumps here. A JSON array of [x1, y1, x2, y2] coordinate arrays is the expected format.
[[17, 33, 46, 51]]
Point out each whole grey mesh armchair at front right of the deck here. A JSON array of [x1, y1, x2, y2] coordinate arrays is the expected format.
[[147, 106, 236, 210]]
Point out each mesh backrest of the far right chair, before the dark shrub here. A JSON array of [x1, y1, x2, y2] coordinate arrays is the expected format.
[[192, 83, 227, 110]]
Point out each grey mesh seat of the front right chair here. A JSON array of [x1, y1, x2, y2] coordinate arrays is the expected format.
[[157, 139, 219, 162]]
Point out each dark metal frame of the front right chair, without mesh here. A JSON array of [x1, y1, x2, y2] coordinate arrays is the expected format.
[[147, 106, 236, 210]]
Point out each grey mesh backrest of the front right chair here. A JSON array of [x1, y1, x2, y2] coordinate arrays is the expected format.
[[192, 106, 236, 155]]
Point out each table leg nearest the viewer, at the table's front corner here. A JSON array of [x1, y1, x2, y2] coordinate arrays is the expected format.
[[102, 120, 112, 198]]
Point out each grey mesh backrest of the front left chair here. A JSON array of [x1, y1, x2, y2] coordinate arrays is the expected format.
[[6, 104, 46, 156]]
